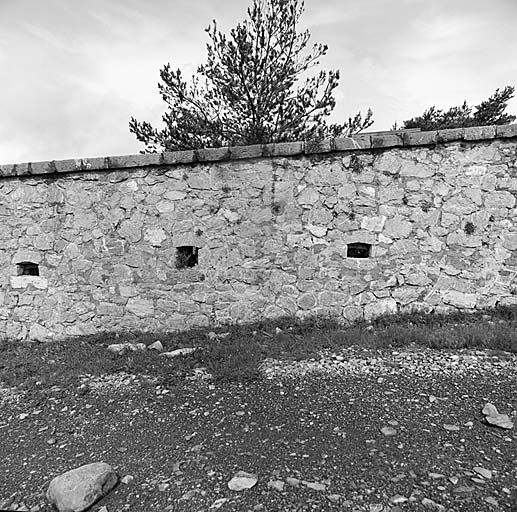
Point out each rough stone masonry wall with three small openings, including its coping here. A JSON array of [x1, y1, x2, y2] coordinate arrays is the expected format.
[[0, 125, 517, 339]]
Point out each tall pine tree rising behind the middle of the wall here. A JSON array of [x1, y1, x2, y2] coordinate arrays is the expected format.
[[129, 0, 373, 152]]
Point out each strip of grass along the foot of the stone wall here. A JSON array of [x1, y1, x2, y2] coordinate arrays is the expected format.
[[0, 307, 517, 391]]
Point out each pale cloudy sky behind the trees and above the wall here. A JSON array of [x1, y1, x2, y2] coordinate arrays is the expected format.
[[0, 0, 517, 163]]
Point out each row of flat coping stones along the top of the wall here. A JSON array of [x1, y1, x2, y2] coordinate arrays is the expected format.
[[0, 124, 517, 179]]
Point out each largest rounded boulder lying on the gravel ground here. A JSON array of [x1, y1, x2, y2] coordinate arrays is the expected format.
[[47, 462, 118, 512]]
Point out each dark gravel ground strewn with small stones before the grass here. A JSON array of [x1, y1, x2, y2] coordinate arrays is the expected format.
[[0, 347, 517, 512]]
